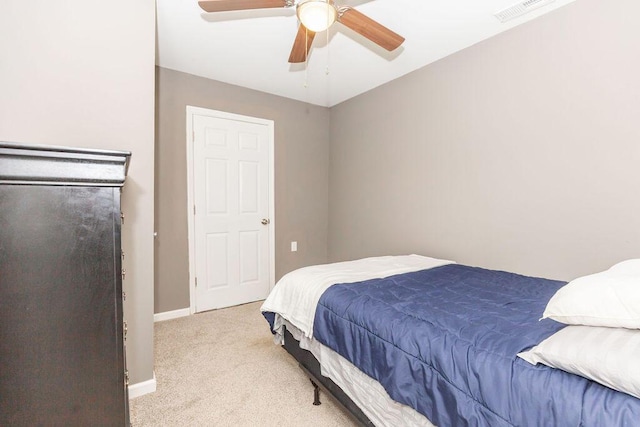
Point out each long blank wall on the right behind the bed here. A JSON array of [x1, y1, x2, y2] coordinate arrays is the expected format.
[[329, 0, 640, 279]]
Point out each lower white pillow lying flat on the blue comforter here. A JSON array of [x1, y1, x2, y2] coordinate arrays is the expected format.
[[518, 326, 640, 399]]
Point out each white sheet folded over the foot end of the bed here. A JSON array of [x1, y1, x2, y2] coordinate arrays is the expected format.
[[260, 254, 453, 343]]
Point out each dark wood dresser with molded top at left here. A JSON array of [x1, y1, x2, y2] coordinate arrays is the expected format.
[[0, 142, 130, 426]]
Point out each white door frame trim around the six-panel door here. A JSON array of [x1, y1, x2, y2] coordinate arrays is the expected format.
[[186, 105, 276, 314]]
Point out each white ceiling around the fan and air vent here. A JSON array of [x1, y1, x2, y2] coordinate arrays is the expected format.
[[156, 0, 574, 107]]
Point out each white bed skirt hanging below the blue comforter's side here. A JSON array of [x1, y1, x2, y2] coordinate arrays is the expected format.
[[284, 315, 435, 427]]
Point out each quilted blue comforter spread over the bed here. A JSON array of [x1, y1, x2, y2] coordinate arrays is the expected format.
[[313, 265, 640, 427]]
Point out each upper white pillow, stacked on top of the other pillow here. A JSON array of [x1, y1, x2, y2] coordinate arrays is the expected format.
[[542, 259, 640, 329]]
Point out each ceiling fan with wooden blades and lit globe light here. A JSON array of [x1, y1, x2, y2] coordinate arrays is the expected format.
[[198, 0, 404, 63]]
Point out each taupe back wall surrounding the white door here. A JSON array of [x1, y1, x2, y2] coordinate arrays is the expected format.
[[155, 68, 329, 313]]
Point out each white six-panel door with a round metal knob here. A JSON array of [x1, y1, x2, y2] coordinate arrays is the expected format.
[[191, 108, 273, 312]]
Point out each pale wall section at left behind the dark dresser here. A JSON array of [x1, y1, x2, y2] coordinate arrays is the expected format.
[[0, 0, 155, 383]]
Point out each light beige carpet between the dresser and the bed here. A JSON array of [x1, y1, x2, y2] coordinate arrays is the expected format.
[[130, 302, 356, 427]]
